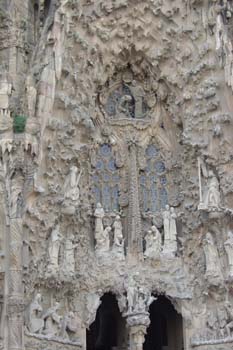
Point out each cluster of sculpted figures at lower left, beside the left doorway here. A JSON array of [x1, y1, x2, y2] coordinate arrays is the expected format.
[[26, 293, 80, 342]]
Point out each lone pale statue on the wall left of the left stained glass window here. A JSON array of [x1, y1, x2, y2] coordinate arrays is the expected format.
[[64, 166, 82, 202]]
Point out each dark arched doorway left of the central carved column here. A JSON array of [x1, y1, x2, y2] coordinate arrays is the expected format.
[[87, 293, 127, 350]]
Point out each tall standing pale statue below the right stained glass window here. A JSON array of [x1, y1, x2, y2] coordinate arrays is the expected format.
[[163, 205, 177, 257]]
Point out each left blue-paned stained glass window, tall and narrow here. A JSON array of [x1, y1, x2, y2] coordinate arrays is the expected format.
[[92, 144, 120, 212]]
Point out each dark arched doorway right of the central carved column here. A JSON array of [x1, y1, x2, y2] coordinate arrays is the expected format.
[[143, 296, 183, 350]]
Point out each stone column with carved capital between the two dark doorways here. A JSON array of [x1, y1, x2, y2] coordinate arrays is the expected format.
[[127, 311, 150, 350]]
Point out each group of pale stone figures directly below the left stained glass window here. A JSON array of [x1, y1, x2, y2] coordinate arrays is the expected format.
[[94, 203, 124, 259]]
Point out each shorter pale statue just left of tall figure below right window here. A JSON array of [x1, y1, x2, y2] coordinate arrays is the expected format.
[[144, 226, 162, 259]]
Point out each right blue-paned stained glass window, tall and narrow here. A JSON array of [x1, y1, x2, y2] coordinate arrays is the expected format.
[[140, 145, 168, 213]]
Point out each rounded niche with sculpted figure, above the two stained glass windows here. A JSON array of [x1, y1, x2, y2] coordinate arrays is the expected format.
[[103, 80, 148, 119]]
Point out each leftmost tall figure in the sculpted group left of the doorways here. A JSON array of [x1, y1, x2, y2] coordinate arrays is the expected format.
[[27, 293, 44, 334]]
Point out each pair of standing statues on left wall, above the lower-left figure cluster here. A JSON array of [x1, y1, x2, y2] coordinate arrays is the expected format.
[[47, 225, 77, 276]]
